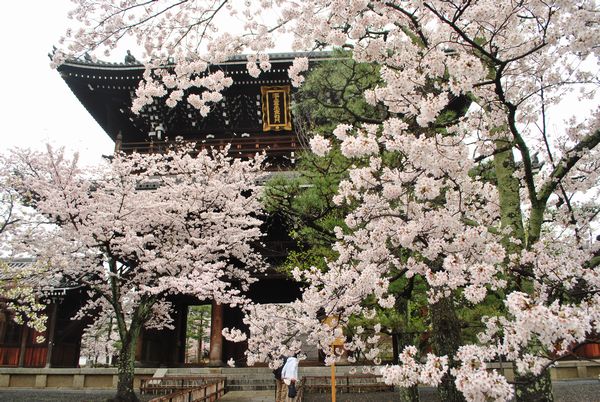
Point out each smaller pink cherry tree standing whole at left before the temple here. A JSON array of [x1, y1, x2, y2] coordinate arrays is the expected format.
[[5, 146, 263, 401]]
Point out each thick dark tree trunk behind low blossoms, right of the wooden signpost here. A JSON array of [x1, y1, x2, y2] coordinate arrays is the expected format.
[[431, 297, 465, 402]]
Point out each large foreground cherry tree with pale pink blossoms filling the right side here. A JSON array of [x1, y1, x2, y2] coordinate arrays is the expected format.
[[54, 0, 600, 401]]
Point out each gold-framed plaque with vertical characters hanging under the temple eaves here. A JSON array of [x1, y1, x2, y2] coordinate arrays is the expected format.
[[260, 85, 292, 131]]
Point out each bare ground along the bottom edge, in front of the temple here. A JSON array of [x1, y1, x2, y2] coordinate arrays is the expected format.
[[0, 380, 600, 402]]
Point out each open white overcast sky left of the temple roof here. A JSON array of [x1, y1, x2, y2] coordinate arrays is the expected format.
[[0, 0, 114, 163]]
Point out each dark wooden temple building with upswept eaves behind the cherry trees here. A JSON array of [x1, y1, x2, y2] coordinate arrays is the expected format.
[[0, 53, 330, 367]]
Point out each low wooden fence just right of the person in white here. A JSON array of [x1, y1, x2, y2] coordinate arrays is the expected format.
[[302, 374, 394, 393]]
